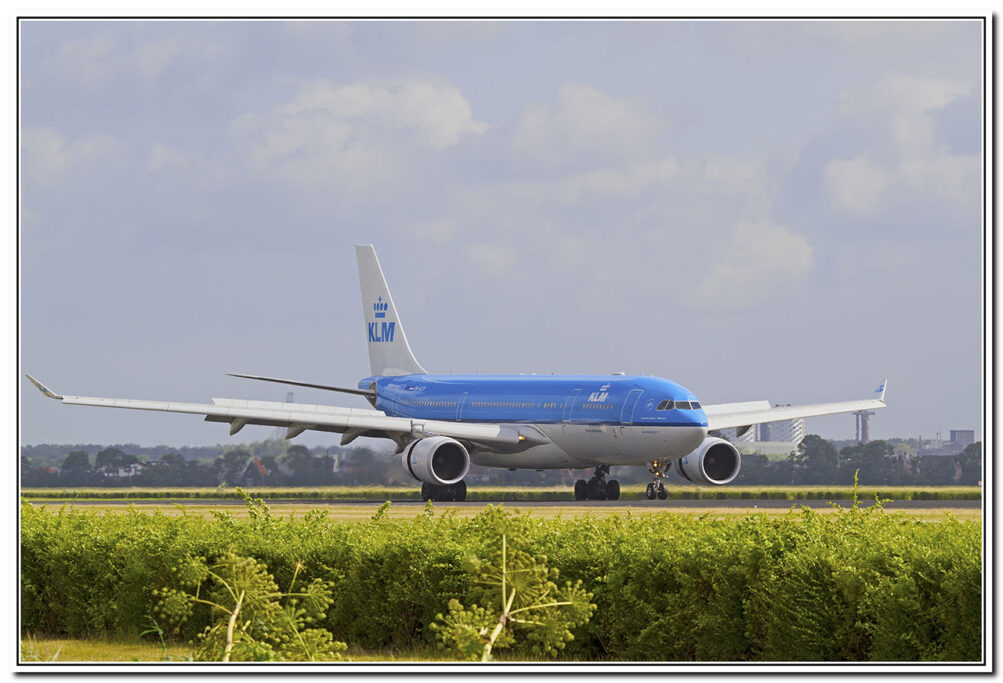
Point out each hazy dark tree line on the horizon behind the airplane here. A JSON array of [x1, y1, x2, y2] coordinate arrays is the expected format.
[[21, 434, 982, 486]]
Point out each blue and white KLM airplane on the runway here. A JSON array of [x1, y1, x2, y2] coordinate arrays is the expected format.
[[26, 245, 888, 501]]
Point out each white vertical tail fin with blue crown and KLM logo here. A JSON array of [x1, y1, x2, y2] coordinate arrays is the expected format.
[[355, 245, 427, 375]]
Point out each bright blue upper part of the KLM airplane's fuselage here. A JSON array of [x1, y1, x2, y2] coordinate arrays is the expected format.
[[359, 375, 707, 427]]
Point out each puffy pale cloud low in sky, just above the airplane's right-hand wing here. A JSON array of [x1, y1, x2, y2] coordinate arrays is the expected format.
[[697, 221, 814, 308]]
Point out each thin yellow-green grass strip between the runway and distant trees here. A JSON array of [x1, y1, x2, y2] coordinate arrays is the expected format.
[[21, 483, 982, 501]]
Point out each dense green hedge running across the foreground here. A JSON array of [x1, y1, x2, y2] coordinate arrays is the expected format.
[[21, 493, 982, 661]]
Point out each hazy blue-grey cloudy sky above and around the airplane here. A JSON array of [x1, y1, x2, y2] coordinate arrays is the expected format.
[[19, 20, 985, 446]]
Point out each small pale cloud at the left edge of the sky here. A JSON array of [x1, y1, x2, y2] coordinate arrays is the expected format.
[[21, 128, 125, 186]]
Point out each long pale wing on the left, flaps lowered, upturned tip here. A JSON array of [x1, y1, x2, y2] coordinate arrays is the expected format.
[[27, 375, 541, 447]]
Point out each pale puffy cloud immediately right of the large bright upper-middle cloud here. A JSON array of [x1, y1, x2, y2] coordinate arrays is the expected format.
[[513, 83, 664, 163]]
